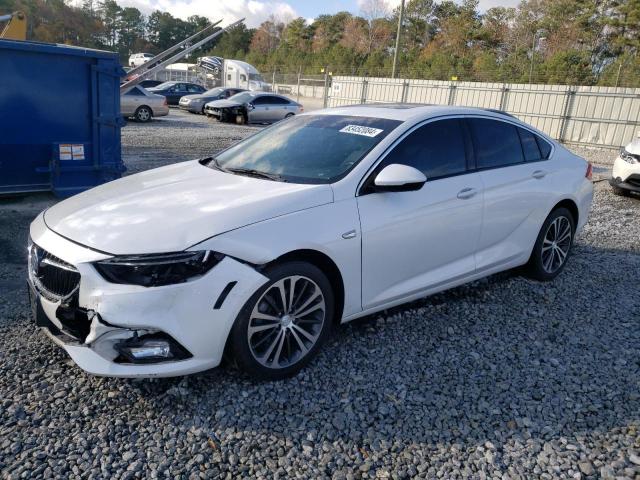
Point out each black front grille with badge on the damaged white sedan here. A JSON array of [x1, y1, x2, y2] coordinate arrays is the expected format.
[[29, 243, 80, 301]]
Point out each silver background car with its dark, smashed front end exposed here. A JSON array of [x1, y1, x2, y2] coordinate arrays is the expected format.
[[204, 92, 304, 123]]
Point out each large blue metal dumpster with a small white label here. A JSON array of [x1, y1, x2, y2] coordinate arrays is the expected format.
[[0, 40, 125, 197]]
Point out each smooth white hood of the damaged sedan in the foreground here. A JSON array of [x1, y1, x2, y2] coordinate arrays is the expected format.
[[44, 161, 333, 255]]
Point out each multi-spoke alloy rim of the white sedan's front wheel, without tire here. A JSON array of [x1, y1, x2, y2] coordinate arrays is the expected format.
[[247, 275, 326, 369]]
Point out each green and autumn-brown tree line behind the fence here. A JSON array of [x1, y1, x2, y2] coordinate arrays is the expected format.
[[0, 0, 640, 87]]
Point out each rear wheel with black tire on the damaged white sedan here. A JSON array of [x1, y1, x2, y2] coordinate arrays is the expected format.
[[525, 207, 576, 282]]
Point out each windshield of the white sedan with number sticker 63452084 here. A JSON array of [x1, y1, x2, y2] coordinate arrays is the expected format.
[[211, 115, 402, 183]]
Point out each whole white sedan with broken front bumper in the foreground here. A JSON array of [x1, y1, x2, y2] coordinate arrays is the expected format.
[[29, 105, 593, 379]]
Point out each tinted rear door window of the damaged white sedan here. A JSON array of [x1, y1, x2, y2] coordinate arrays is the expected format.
[[467, 118, 524, 168]]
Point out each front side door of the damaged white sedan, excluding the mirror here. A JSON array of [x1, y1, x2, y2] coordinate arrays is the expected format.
[[357, 118, 483, 309]]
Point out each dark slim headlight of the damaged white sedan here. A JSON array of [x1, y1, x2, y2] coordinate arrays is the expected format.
[[93, 250, 224, 287]]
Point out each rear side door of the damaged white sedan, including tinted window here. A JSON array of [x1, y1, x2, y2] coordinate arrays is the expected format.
[[466, 117, 553, 271]]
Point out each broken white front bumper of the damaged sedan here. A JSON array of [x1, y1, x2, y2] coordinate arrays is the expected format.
[[30, 214, 267, 377]]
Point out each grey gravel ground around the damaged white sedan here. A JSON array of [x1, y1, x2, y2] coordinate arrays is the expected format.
[[0, 111, 640, 479]]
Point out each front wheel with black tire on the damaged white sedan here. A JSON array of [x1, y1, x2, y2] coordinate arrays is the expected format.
[[229, 261, 334, 380]]
